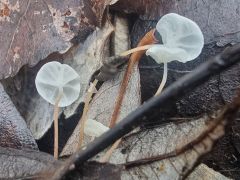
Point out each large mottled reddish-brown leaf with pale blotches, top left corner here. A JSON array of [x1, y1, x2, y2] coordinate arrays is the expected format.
[[0, 0, 117, 79]]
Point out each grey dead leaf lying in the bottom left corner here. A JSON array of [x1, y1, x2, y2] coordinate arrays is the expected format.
[[0, 147, 61, 179]]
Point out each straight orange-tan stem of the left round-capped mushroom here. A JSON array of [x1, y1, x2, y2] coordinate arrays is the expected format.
[[53, 91, 63, 159]]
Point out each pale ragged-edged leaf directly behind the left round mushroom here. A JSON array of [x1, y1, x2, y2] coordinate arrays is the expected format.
[[0, 13, 113, 139]]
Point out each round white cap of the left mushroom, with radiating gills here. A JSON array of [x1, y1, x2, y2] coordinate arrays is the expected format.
[[35, 61, 80, 107]]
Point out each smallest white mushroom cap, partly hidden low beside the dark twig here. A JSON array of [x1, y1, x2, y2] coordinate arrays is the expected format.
[[84, 119, 109, 137]]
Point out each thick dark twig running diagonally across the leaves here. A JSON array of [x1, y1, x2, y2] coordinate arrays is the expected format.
[[51, 44, 240, 179]]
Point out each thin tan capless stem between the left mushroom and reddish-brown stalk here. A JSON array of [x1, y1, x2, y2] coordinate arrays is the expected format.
[[78, 79, 98, 149]]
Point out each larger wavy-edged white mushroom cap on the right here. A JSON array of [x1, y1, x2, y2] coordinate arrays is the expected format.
[[146, 13, 204, 63]]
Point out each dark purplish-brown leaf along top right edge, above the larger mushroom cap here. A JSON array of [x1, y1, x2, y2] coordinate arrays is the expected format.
[[112, 0, 240, 46]]
